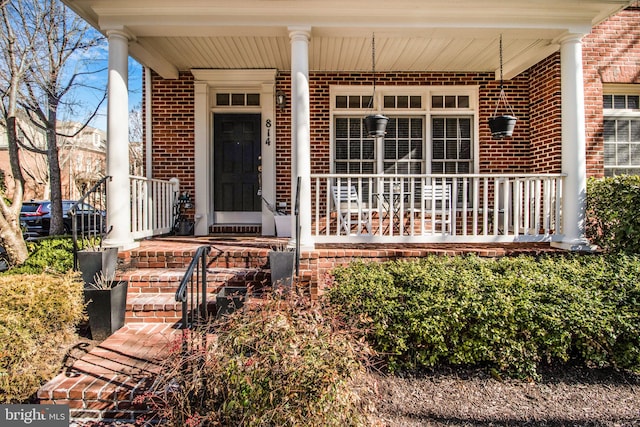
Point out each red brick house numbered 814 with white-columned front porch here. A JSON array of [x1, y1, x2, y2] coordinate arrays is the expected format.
[[64, 0, 640, 249]]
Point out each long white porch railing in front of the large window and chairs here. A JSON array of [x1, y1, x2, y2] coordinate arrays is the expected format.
[[311, 174, 564, 243]]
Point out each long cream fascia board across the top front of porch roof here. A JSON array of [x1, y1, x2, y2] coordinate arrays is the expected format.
[[82, 0, 628, 36]]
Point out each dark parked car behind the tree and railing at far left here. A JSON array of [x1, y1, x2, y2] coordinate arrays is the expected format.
[[20, 200, 105, 238]]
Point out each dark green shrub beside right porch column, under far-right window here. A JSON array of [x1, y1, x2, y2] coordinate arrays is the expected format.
[[586, 175, 640, 253]]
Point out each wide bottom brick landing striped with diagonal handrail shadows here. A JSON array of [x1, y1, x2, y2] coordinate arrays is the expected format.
[[37, 323, 180, 422]]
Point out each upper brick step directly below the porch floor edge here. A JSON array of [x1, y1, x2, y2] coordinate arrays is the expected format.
[[118, 268, 271, 296]]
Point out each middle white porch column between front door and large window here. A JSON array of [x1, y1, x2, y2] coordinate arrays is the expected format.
[[289, 27, 314, 250]]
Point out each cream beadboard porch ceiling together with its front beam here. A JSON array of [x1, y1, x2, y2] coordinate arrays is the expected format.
[[63, 0, 632, 78]]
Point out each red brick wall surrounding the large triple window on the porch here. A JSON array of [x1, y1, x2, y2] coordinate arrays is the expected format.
[[276, 72, 531, 204]]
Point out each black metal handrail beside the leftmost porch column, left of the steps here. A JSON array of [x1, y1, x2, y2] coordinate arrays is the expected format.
[[68, 176, 111, 270]]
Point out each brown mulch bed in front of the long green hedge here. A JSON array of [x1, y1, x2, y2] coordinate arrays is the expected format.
[[376, 367, 640, 427]]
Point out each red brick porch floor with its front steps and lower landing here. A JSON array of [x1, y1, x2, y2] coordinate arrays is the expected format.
[[38, 236, 558, 425]]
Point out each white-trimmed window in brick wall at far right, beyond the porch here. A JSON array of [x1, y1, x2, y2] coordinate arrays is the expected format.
[[603, 85, 640, 176]]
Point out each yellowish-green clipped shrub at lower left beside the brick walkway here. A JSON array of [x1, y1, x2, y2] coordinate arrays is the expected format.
[[0, 274, 84, 403]]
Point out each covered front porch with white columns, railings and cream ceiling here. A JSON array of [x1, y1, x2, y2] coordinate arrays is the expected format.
[[58, 0, 629, 251]]
